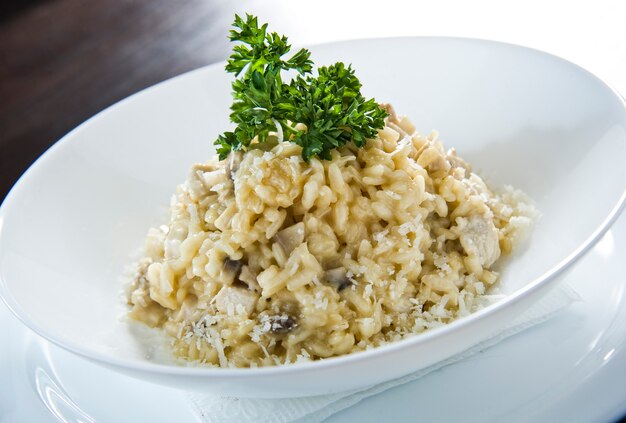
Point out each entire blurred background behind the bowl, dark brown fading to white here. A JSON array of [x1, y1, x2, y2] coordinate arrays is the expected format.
[[0, 0, 626, 420]]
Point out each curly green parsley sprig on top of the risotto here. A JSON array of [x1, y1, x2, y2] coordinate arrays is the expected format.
[[215, 15, 388, 162]]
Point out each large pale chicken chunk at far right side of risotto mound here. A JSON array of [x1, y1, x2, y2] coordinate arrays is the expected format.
[[456, 214, 500, 267]]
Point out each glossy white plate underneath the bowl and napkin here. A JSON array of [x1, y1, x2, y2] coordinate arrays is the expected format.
[[0, 210, 626, 423]]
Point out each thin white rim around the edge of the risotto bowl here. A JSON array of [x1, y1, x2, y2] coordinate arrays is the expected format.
[[0, 36, 626, 379]]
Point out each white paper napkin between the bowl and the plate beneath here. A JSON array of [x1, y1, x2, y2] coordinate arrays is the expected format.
[[188, 284, 580, 423]]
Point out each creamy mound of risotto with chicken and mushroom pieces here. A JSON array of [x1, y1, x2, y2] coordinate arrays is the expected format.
[[129, 106, 534, 367]]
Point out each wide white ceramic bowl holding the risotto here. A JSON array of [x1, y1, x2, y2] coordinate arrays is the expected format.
[[0, 38, 626, 397]]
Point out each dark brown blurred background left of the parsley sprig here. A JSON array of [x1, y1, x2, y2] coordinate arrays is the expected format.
[[0, 0, 241, 201]]
